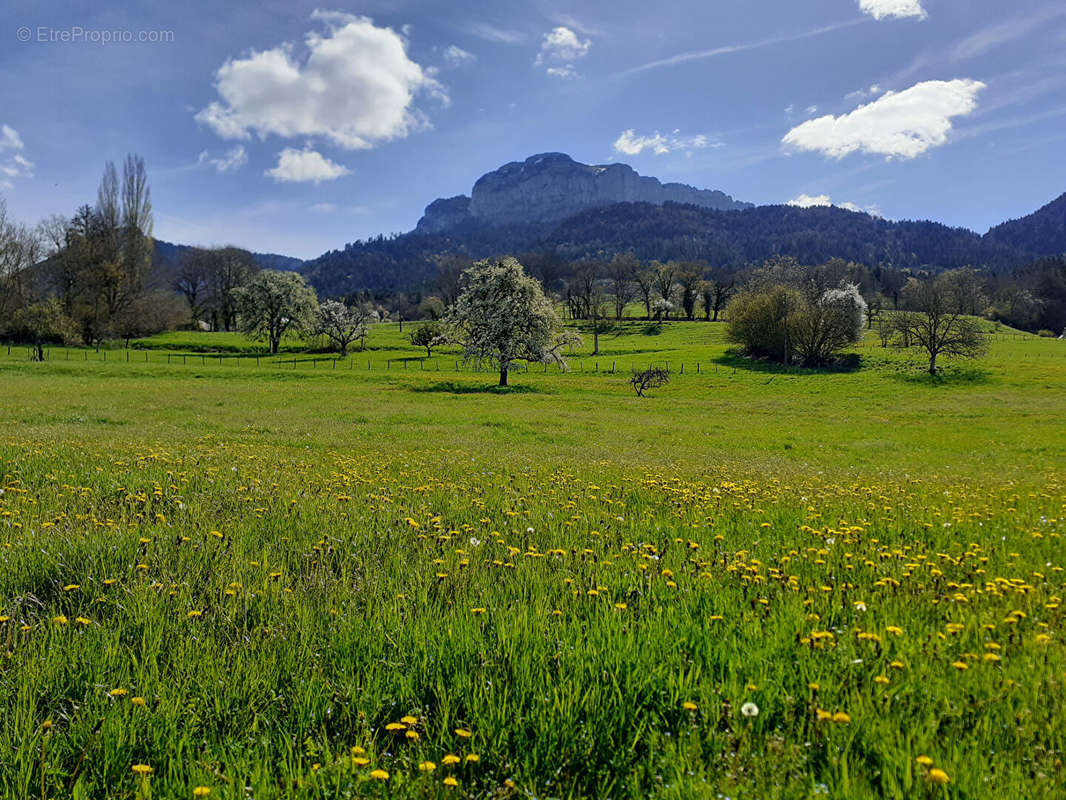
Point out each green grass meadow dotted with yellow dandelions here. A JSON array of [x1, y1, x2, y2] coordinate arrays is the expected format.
[[0, 322, 1066, 799]]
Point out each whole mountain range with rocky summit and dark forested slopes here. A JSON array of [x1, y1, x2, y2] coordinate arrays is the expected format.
[[302, 154, 1066, 297]]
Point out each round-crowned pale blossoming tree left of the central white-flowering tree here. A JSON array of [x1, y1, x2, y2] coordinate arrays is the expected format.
[[233, 270, 318, 353]]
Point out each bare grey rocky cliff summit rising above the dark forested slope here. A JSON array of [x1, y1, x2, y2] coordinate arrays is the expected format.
[[417, 153, 752, 233]]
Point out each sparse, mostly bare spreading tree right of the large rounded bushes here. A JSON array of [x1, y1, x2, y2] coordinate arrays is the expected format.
[[897, 273, 988, 375]]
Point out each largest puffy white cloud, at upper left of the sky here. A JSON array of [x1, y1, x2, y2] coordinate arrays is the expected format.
[[196, 11, 447, 149]]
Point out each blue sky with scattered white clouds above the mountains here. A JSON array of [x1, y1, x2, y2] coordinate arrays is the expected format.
[[6, 0, 1066, 258]]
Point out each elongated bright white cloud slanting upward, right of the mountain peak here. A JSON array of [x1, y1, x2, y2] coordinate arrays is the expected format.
[[781, 79, 985, 159]]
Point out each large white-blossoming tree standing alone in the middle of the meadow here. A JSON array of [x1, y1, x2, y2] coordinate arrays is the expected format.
[[447, 256, 574, 386]]
